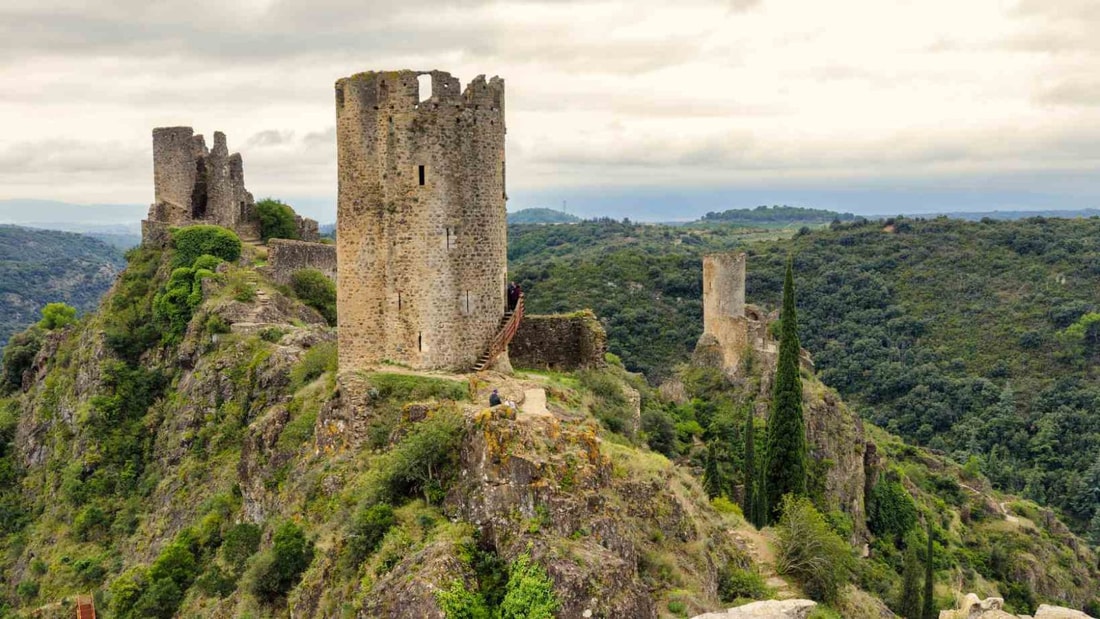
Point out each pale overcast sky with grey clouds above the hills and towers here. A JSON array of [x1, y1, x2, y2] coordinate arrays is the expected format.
[[0, 0, 1100, 221]]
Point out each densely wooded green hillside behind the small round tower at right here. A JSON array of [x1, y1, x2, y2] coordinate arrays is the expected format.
[[509, 218, 1100, 543]]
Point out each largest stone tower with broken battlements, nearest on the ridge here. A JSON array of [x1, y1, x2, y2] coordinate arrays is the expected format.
[[336, 70, 507, 369]]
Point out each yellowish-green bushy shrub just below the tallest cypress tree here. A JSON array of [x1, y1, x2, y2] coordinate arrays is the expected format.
[[776, 495, 855, 604]]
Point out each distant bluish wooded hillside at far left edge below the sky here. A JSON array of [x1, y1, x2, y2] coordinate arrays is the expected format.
[[0, 225, 125, 343]]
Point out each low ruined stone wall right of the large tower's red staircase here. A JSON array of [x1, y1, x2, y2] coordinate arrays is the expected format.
[[508, 310, 607, 371]]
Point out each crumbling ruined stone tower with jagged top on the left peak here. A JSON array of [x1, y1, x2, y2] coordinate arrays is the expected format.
[[142, 126, 260, 244]]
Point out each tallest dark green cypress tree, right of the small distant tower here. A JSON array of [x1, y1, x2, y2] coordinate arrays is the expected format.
[[765, 258, 807, 522]]
